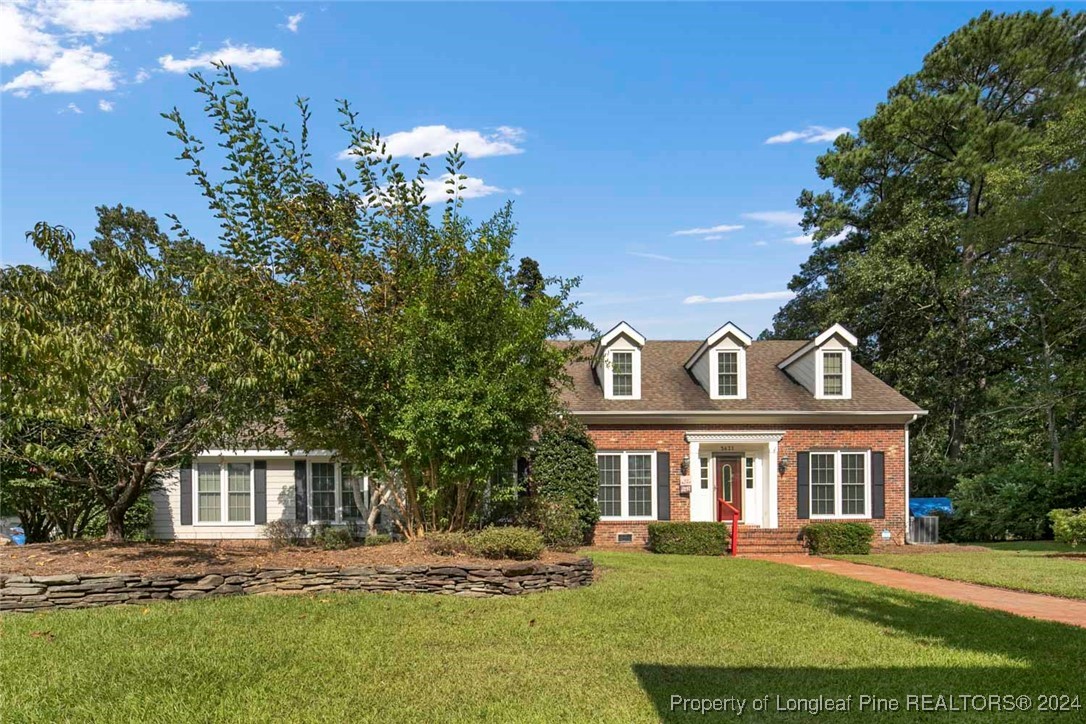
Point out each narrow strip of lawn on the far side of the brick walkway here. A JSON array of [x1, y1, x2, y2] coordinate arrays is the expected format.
[[839, 541, 1086, 599]]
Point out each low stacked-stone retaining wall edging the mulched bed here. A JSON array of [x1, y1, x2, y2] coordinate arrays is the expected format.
[[0, 558, 592, 611]]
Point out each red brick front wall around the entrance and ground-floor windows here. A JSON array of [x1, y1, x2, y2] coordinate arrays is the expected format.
[[589, 424, 907, 545]]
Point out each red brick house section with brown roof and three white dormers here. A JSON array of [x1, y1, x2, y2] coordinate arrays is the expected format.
[[564, 322, 924, 552]]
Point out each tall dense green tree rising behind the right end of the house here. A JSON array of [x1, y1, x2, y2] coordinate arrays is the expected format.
[[772, 11, 1086, 475]]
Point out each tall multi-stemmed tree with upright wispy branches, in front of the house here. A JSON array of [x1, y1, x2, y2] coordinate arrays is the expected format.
[[165, 66, 589, 537]]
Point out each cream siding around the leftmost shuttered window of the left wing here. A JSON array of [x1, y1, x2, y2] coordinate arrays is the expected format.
[[151, 458, 294, 539]]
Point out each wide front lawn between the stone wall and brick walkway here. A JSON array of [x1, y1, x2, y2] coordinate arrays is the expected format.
[[0, 552, 1086, 722]]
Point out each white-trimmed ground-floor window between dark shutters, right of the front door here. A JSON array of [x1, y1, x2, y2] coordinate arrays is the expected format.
[[810, 450, 871, 518]]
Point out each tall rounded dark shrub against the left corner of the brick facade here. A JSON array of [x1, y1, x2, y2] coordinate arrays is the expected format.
[[531, 415, 599, 535]]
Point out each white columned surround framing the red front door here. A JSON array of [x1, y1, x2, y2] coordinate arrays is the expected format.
[[685, 430, 784, 528]]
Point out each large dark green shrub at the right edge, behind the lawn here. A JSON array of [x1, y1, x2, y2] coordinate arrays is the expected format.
[[950, 463, 1086, 541]]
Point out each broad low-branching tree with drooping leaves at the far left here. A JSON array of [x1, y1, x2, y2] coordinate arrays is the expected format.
[[0, 206, 299, 541]]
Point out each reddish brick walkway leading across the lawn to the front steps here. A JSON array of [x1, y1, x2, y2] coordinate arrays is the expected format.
[[750, 556, 1086, 628]]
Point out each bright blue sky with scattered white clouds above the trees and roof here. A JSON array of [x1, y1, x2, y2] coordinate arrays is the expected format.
[[0, 0, 1077, 339]]
